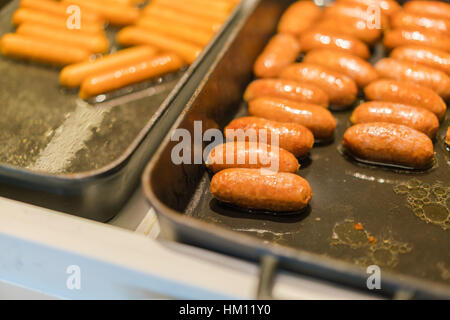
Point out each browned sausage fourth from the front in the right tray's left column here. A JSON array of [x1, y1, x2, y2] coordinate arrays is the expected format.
[[248, 97, 336, 140]]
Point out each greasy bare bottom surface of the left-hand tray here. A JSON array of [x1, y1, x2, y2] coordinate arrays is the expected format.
[[0, 0, 182, 174]]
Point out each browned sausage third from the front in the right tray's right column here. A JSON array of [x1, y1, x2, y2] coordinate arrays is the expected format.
[[364, 79, 447, 120]]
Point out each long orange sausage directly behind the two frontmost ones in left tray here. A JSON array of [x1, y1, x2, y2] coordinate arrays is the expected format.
[[117, 27, 202, 64]]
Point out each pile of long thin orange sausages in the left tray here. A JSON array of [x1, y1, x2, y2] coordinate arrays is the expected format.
[[0, 0, 238, 99]]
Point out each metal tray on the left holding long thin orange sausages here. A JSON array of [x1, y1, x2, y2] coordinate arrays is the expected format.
[[0, 0, 240, 221]]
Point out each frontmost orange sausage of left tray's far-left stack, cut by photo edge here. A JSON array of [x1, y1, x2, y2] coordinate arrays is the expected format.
[[0, 33, 90, 66]]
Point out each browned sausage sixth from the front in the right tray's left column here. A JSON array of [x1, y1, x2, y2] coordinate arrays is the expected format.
[[280, 63, 358, 108]]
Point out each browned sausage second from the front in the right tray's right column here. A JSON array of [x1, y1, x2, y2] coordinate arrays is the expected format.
[[350, 101, 439, 138]]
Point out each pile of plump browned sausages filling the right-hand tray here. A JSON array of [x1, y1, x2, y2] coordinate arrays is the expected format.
[[209, 0, 450, 211]]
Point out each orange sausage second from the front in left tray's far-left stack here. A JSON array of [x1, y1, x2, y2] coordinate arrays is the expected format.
[[16, 22, 109, 53]]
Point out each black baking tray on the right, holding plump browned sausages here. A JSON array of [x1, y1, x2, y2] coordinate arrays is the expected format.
[[142, 0, 450, 298]]
